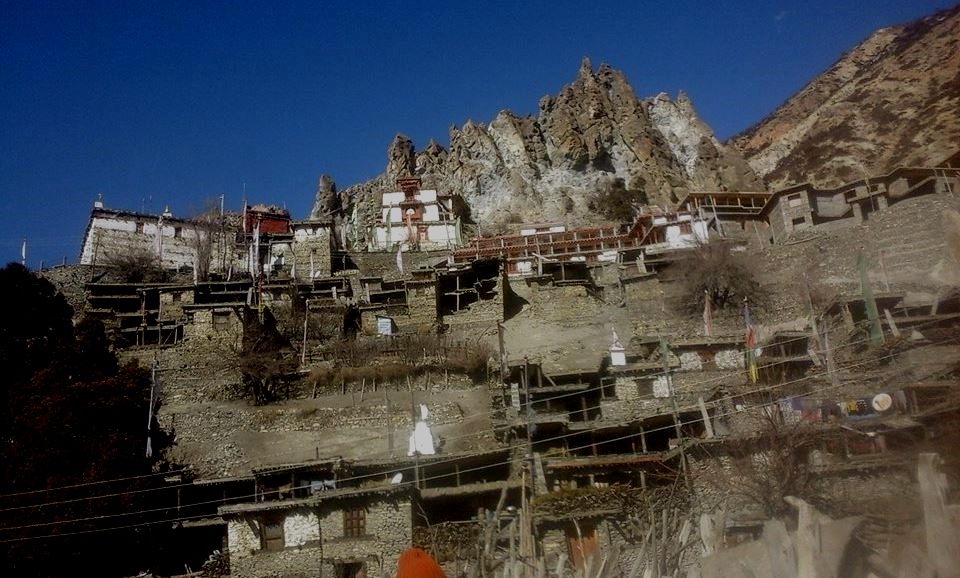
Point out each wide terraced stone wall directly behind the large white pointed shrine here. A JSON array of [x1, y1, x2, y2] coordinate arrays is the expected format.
[[158, 378, 496, 479]]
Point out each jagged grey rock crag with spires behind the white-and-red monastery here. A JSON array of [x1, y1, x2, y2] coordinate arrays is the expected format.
[[332, 59, 762, 237]]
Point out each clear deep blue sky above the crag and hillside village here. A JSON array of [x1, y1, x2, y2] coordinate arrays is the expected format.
[[0, 0, 951, 267]]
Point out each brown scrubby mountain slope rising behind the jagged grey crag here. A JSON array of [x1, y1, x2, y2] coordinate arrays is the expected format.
[[734, 6, 960, 189]]
